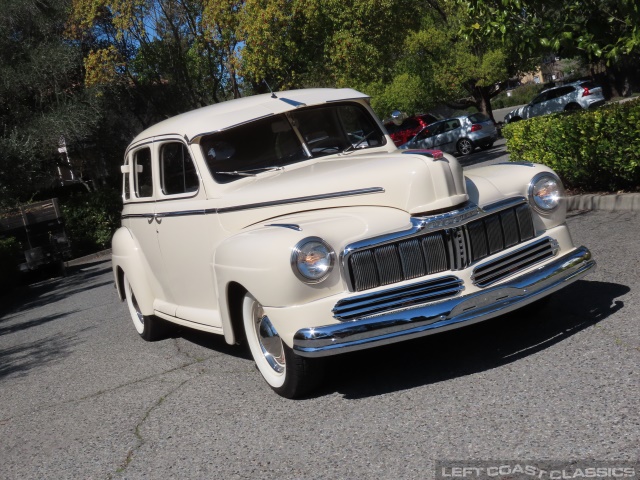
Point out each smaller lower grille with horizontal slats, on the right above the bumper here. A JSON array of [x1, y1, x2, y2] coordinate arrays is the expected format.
[[471, 237, 558, 287]]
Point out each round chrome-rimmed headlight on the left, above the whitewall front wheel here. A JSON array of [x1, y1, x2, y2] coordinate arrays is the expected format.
[[291, 237, 335, 283]]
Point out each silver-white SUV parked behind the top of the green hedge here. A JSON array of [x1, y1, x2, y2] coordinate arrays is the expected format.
[[504, 81, 605, 123]]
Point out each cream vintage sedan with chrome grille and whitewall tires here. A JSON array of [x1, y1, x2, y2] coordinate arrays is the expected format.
[[113, 89, 595, 397]]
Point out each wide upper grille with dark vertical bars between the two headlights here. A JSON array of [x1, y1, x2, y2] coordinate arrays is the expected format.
[[346, 204, 534, 292]]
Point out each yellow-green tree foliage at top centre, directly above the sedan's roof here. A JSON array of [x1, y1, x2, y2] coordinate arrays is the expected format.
[[240, 0, 418, 90]]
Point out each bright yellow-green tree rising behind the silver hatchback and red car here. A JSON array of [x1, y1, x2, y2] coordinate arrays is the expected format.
[[368, 0, 539, 122]]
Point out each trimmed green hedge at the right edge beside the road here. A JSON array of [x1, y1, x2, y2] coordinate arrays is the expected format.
[[502, 100, 640, 192]]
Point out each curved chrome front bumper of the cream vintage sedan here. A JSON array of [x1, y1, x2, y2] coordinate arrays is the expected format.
[[293, 247, 596, 357]]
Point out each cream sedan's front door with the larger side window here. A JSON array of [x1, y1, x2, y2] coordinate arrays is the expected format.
[[154, 137, 222, 327]]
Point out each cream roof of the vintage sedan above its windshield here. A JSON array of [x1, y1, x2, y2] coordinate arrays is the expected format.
[[131, 88, 369, 145]]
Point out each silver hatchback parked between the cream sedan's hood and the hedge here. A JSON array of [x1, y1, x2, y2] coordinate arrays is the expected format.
[[398, 113, 498, 155]]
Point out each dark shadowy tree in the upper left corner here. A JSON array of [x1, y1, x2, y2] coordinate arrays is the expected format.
[[0, 0, 100, 204]]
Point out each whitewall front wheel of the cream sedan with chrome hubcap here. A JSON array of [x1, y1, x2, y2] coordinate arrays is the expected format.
[[242, 293, 321, 398]]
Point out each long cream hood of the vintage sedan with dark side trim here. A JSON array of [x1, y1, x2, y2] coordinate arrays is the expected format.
[[216, 152, 468, 231]]
